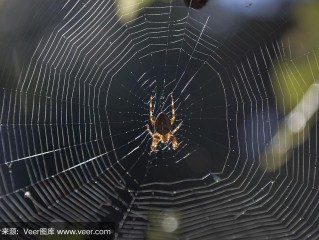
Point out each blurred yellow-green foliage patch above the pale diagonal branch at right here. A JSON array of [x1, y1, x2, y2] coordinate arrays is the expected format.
[[271, 1, 319, 114]]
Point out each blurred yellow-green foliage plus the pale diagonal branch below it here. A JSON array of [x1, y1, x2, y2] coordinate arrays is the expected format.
[[260, 1, 319, 171]]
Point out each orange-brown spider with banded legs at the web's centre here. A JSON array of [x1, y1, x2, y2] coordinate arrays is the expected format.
[[146, 95, 182, 152]]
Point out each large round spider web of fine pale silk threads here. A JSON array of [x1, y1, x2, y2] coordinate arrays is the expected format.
[[0, 1, 319, 239]]
